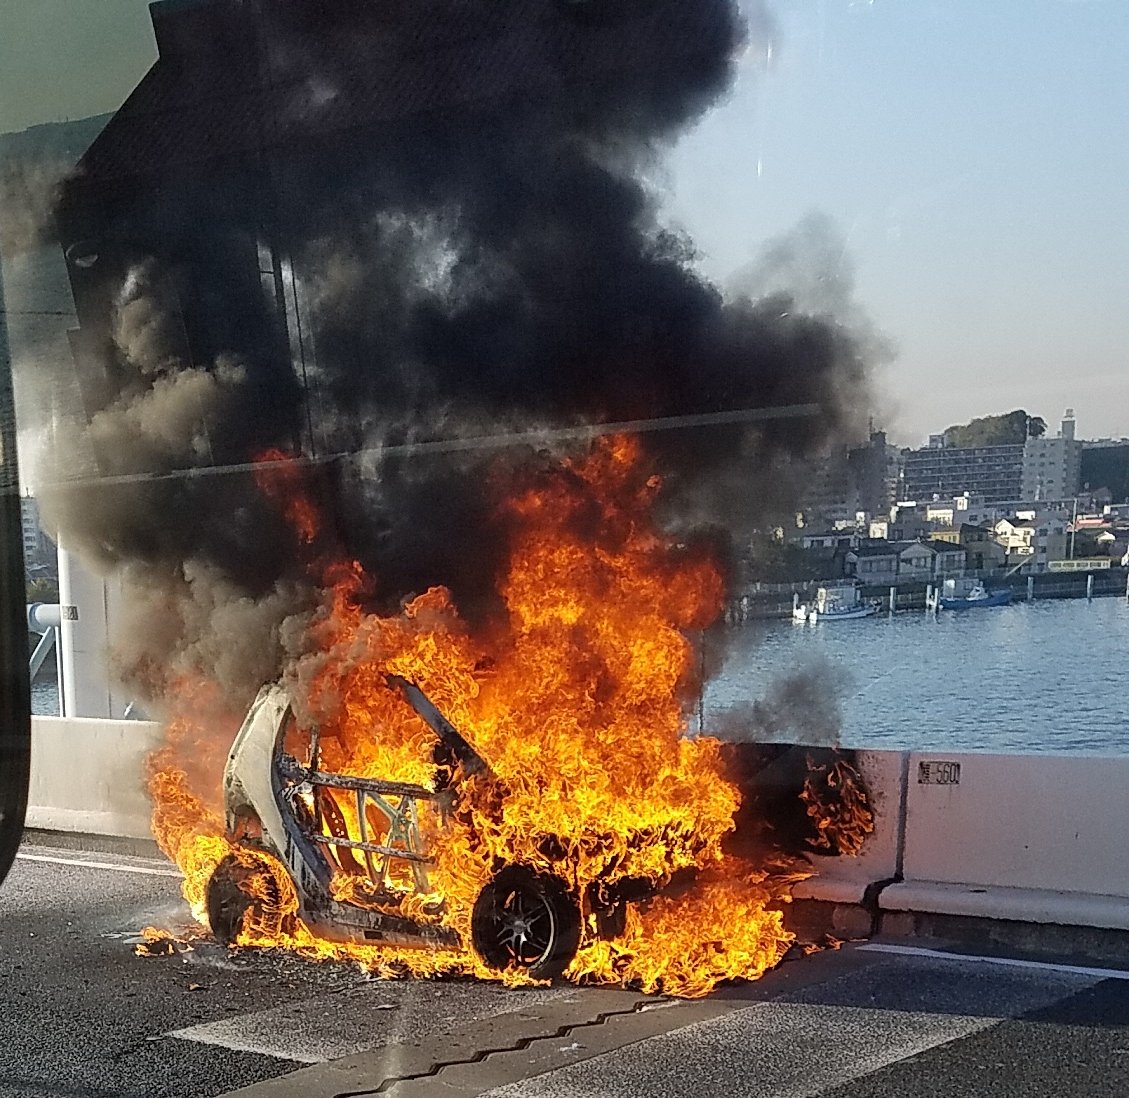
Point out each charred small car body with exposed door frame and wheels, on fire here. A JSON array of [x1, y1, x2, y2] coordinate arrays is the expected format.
[[205, 675, 686, 978]]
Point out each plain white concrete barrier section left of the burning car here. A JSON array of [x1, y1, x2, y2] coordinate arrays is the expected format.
[[27, 717, 160, 838]]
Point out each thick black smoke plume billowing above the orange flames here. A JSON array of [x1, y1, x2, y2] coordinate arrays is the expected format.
[[39, 0, 866, 713]]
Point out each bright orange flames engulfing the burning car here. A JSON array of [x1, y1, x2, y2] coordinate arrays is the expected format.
[[143, 438, 860, 995]]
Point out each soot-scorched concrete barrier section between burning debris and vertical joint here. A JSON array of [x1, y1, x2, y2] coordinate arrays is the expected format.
[[793, 752, 908, 904]]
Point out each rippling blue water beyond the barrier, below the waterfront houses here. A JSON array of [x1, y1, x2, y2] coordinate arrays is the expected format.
[[703, 598, 1129, 755]]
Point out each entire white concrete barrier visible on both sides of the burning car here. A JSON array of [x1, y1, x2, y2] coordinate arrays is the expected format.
[[27, 717, 1129, 947]]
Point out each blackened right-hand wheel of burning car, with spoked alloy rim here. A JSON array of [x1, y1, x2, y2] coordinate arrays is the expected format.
[[471, 866, 580, 980]]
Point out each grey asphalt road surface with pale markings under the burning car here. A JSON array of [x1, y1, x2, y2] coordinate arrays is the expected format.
[[0, 846, 1129, 1098]]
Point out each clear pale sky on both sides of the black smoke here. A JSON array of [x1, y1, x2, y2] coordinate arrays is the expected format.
[[0, 0, 1129, 443]]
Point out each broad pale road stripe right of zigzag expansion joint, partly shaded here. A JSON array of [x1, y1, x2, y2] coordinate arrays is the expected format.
[[482, 950, 1102, 1098]]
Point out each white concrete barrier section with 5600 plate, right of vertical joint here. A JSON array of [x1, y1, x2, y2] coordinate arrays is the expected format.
[[879, 752, 1129, 930]]
